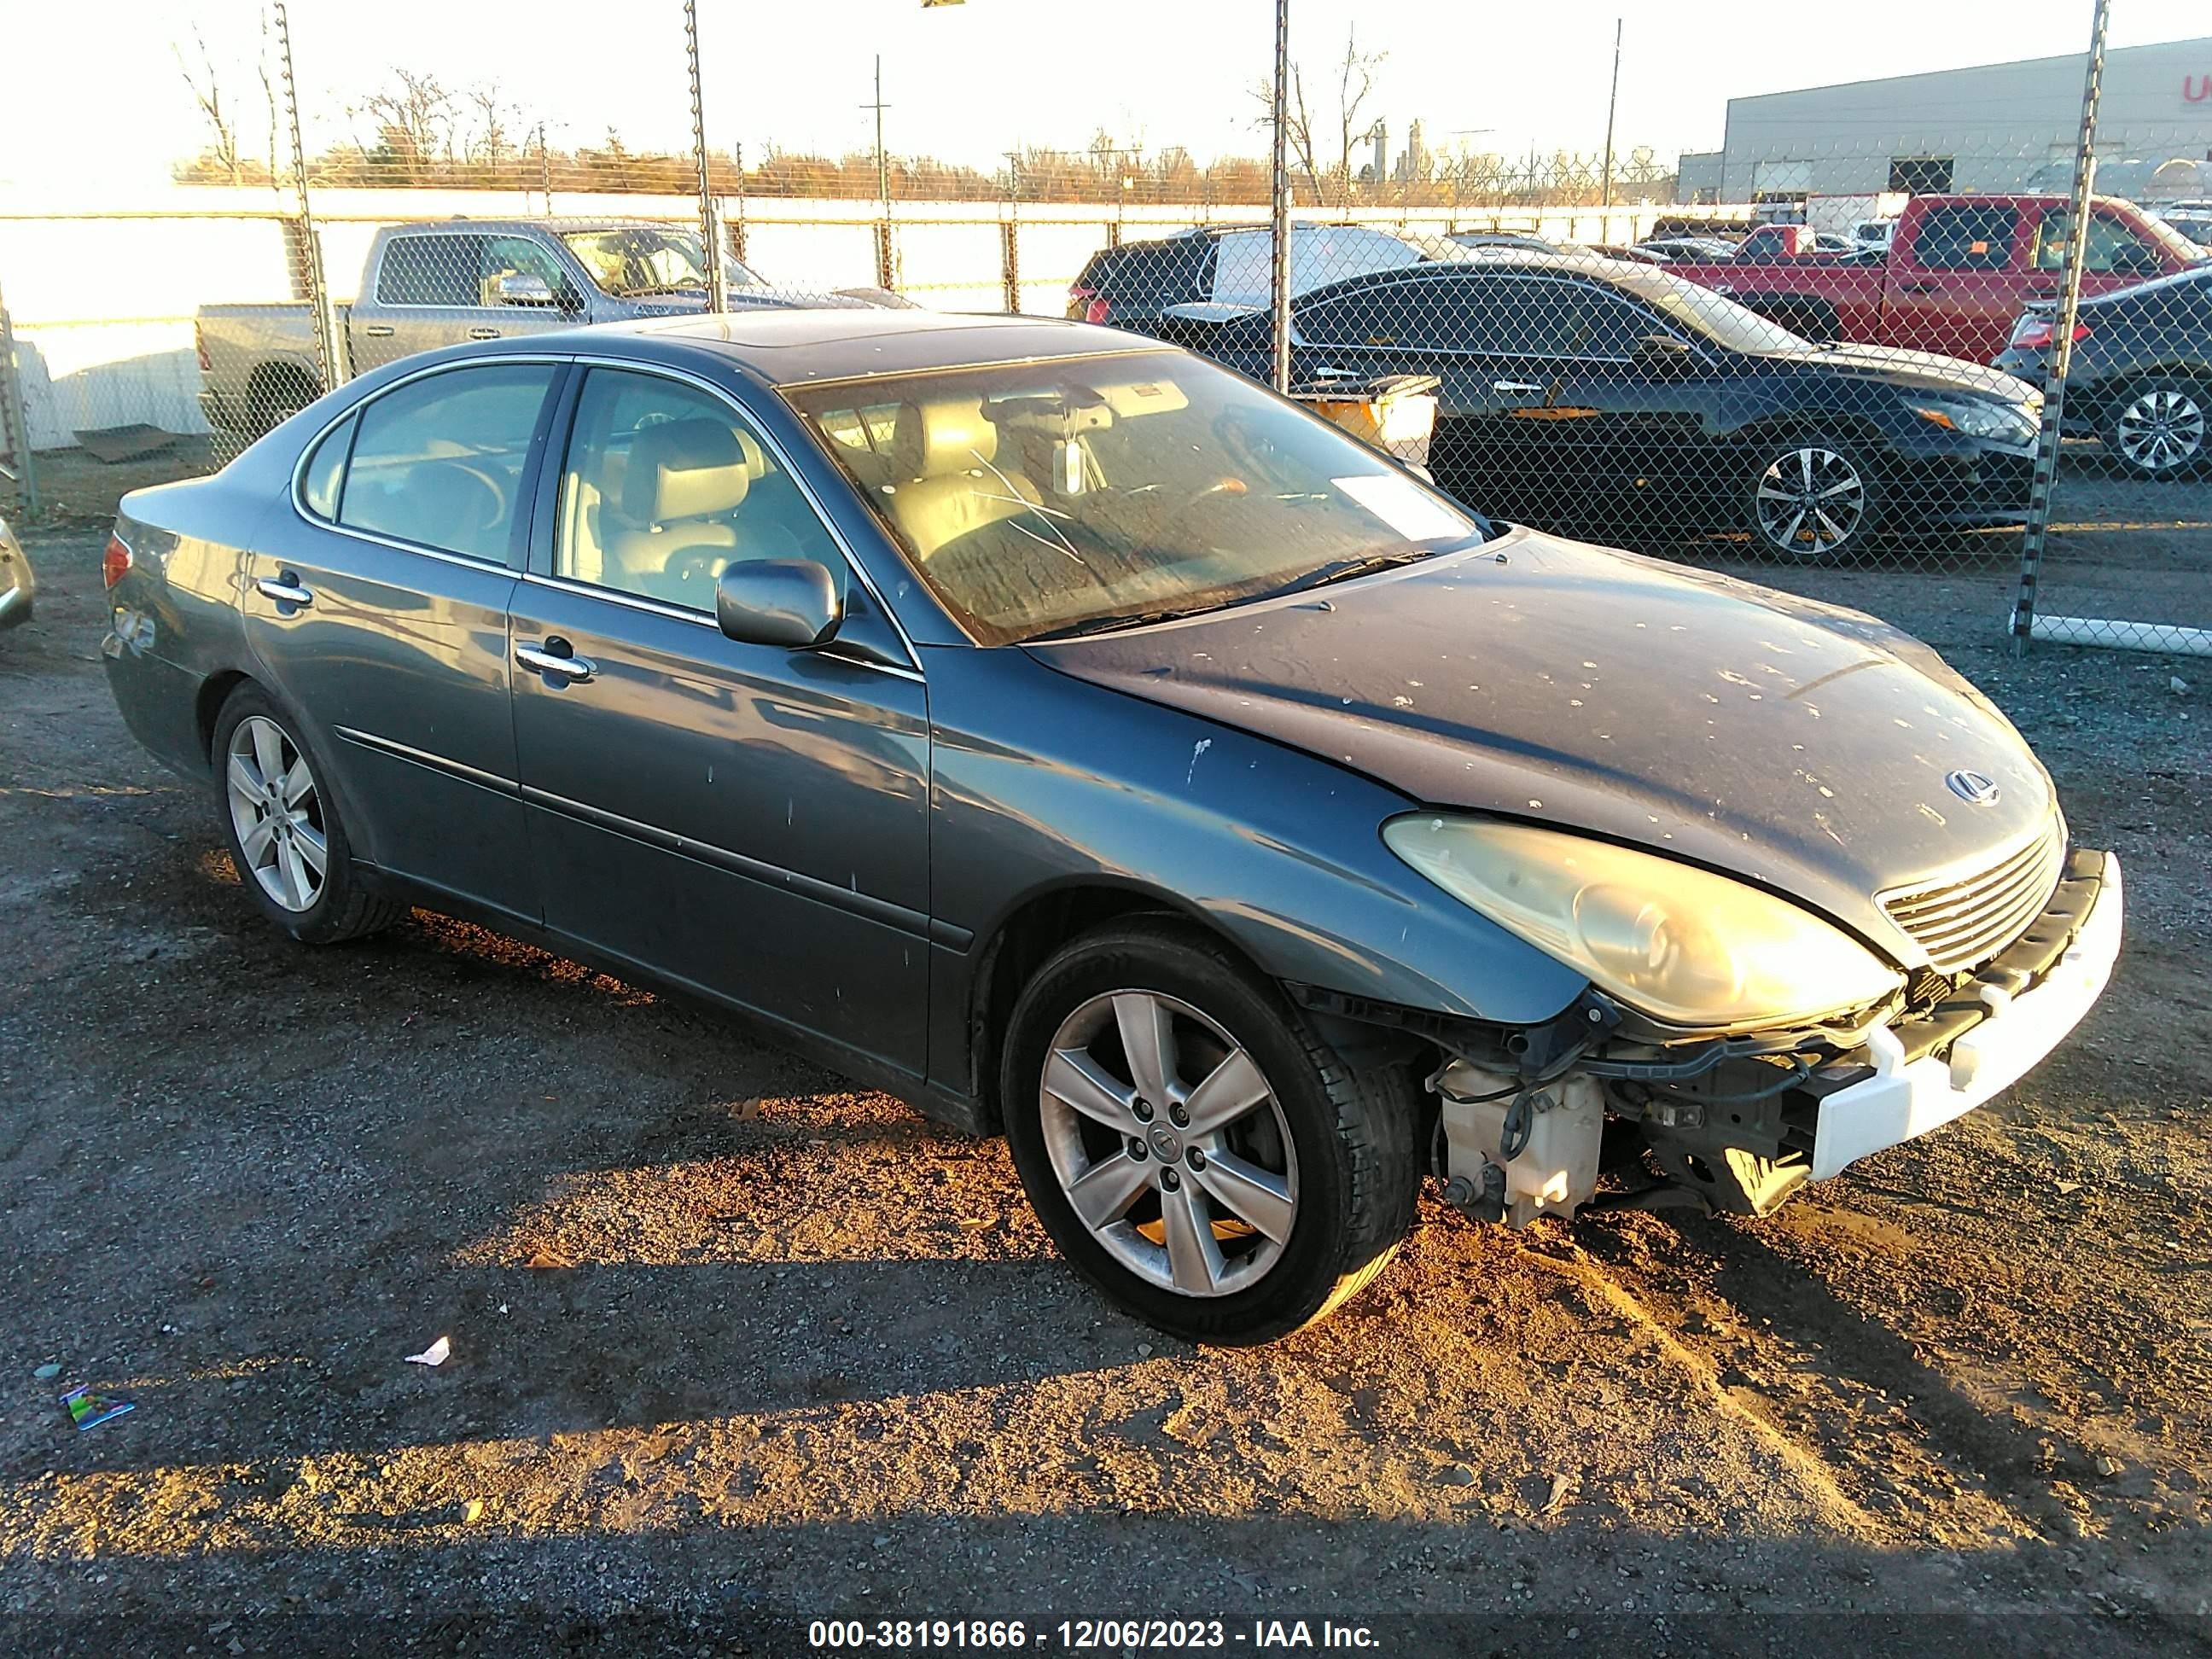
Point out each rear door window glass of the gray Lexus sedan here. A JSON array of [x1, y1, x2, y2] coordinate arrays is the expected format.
[[338, 363, 556, 564]]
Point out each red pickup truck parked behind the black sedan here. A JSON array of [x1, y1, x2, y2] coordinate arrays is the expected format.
[[1668, 195, 2205, 363]]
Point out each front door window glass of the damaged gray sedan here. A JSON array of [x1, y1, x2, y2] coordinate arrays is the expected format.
[[553, 370, 849, 610]]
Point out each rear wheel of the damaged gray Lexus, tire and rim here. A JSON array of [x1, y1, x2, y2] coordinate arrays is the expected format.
[[212, 684, 407, 945]]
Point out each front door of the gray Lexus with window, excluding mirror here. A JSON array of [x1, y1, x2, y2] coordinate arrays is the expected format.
[[511, 367, 929, 1077]]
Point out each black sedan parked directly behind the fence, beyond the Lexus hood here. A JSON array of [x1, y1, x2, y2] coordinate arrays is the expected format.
[[1208, 254, 2041, 560]]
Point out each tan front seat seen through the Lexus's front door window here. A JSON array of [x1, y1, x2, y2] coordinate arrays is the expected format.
[[602, 420, 767, 604]]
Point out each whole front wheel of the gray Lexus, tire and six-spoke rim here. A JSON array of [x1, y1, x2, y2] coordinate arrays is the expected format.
[[1000, 920, 1420, 1342]]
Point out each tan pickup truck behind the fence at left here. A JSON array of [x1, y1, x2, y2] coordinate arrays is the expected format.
[[195, 219, 905, 436]]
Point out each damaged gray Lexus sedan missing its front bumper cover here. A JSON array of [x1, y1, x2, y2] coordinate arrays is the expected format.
[[104, 311, 2122, 1342]]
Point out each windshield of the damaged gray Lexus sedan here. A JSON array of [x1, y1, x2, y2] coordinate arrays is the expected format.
[[783, 352, 1484, 646]]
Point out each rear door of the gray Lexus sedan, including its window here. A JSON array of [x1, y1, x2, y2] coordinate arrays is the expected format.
[[242, 360, 567, 923]]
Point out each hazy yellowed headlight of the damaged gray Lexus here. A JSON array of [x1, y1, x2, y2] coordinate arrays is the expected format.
[[1382, 812, 1905, 1028]]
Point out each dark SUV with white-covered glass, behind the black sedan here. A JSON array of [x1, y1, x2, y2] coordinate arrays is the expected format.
[[1068, 224, 1458, 334]]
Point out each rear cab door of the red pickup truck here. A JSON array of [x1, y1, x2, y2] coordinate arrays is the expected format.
[[1883, 201, 2030, 363]]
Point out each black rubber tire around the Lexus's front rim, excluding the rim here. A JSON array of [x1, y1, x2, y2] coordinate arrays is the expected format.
[[1000, 927, 1358, 1342]]
